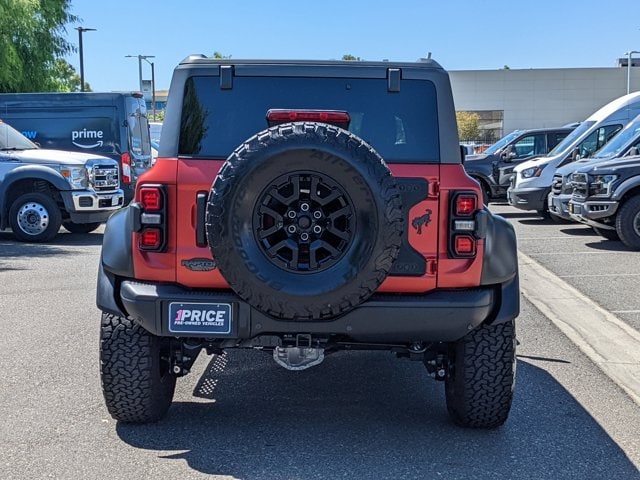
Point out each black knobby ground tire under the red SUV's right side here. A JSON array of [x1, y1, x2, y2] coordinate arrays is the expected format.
[[445, 320, 516, 428]]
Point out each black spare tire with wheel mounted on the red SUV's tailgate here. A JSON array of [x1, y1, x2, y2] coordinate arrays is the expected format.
[[206, 122, 404, 320]]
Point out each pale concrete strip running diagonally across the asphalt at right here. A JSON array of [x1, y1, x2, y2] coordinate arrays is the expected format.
[[518, 252, 640, 405]]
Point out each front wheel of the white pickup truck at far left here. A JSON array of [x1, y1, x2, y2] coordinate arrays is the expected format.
[[9, 192, 62, 242]]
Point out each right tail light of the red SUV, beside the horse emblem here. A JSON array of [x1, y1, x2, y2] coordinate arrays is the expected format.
[[449, 192, 480, 258]]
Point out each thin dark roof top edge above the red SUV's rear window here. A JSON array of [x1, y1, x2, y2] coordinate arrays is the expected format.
[[180, 54, 444, 70]]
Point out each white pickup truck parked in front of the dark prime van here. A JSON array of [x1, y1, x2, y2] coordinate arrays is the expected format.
[[0, 121, 124, 242]]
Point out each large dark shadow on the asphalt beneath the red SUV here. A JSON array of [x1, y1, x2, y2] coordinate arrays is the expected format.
[[116, 351, 640, 480]]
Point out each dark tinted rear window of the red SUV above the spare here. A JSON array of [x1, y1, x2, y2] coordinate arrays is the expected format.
[[179, 77, 439, 163]]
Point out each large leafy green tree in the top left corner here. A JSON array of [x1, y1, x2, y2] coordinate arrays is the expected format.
[[0, 0, 78, 92]]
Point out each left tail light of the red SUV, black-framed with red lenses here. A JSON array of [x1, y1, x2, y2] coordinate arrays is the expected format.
[[131, 185, 167, 252]]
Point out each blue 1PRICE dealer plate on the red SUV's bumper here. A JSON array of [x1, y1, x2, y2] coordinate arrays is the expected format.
[[169, 302, 232, 335]]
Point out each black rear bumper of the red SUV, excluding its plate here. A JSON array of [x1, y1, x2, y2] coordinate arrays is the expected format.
[[97, 268, 520, 344]]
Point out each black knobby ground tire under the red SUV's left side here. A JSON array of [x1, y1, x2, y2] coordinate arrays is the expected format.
[[100, 313, 176, 423]]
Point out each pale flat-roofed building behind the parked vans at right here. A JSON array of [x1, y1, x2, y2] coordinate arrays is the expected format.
[[449, 58, 640, 139]]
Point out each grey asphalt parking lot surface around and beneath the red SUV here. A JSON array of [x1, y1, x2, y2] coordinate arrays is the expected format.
[[0, 205, 640, 479]]
